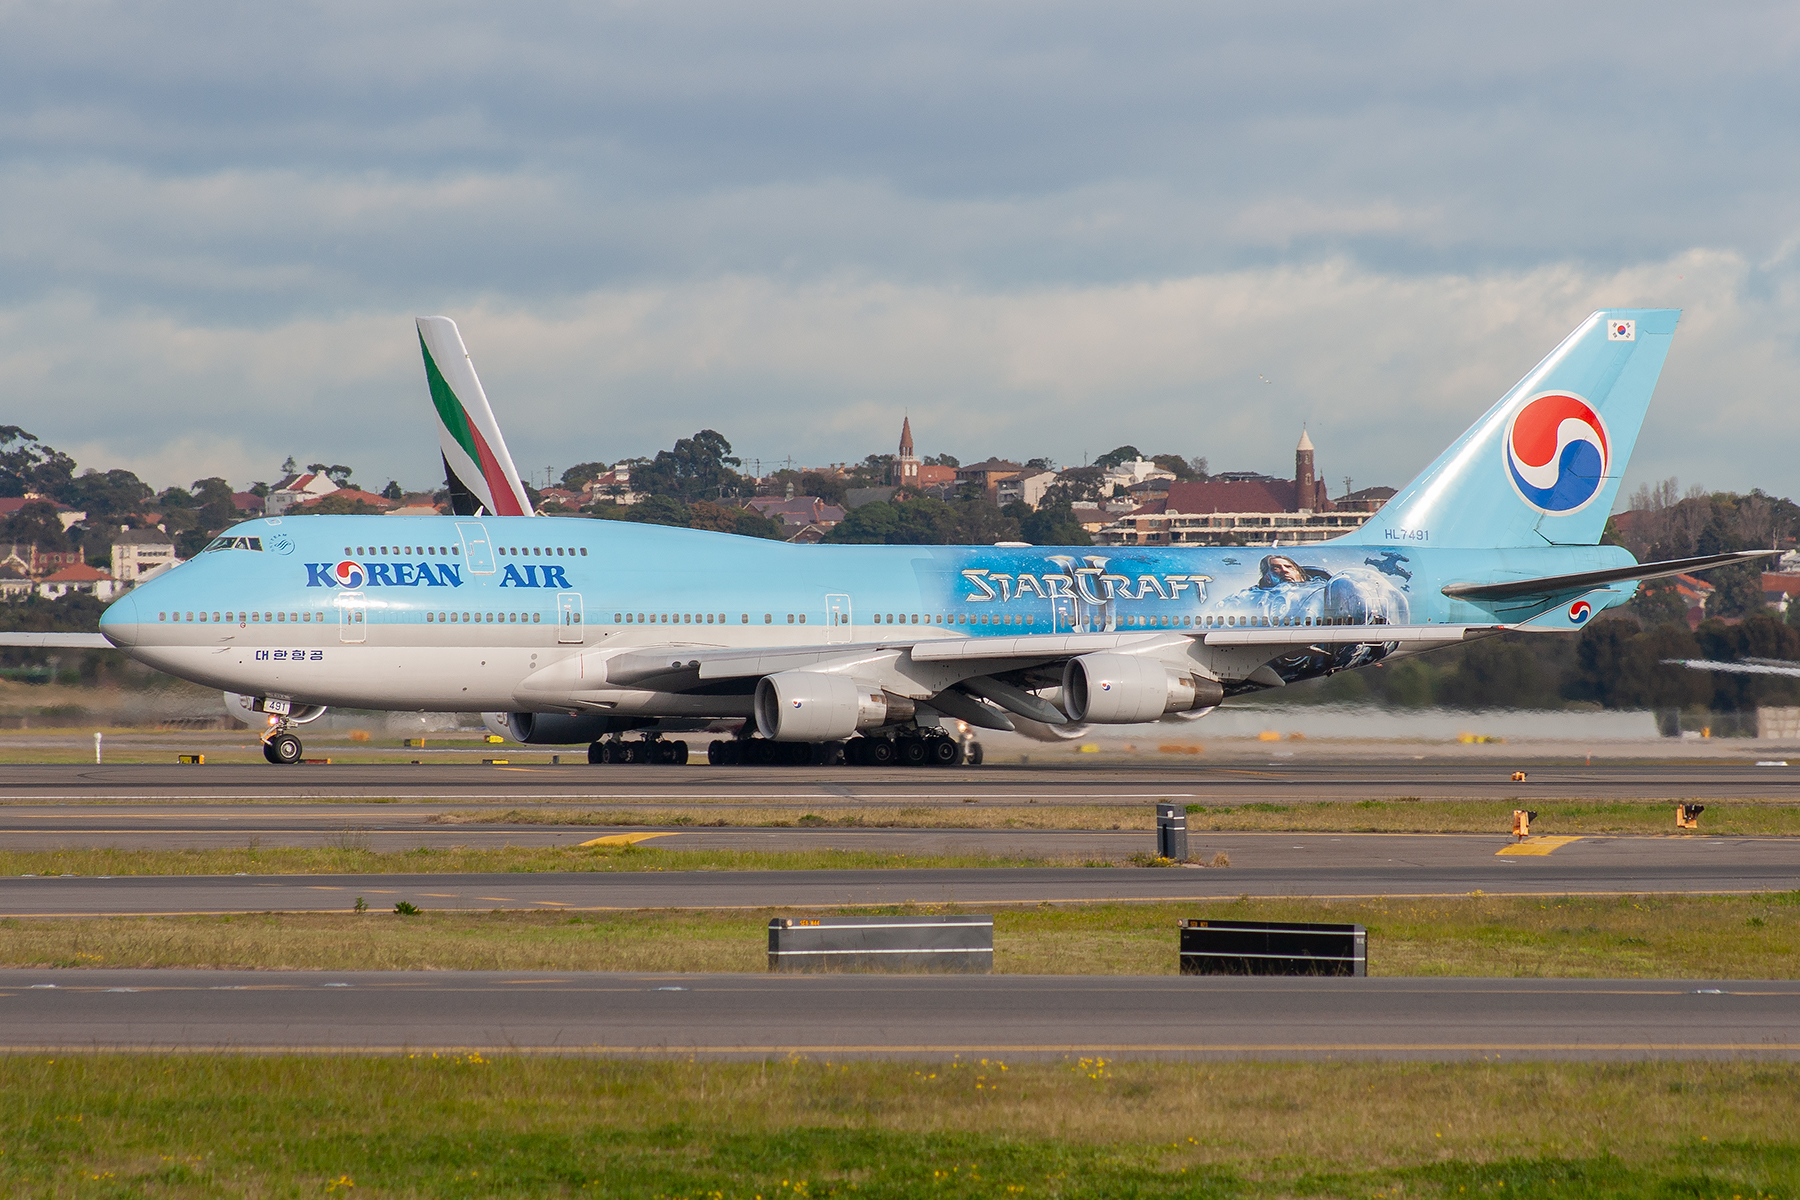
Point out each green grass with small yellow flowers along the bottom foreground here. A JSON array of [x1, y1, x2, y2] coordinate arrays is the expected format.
[[0, 1054, 1800, 1200]]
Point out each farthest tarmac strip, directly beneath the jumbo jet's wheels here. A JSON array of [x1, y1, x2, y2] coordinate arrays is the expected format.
[[0, 766, 1800, 808]]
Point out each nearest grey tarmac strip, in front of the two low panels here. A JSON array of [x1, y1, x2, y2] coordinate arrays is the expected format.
[[0, 970, 1800, 1061]]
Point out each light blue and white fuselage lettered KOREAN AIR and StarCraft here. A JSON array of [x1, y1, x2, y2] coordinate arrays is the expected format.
[[101, 516, 1633, 712]]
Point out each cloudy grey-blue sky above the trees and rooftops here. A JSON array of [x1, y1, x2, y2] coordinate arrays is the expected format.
[[0, 0, 1800, 495]]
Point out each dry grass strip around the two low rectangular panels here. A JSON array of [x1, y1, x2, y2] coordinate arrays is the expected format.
[[0, 892, 1800, 979]]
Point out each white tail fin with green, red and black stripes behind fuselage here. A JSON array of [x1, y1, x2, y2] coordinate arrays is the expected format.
[[418, 317, 531, 516]]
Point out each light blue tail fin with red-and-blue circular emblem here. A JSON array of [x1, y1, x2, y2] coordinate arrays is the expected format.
[[1350, 308, 1681, 549]]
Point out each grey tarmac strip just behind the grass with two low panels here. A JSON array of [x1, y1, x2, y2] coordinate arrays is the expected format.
[[0, 831, 1800, 918]]
